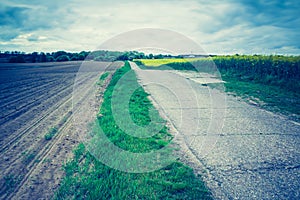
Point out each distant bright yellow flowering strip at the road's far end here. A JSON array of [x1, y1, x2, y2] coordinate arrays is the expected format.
[[134, 58, 203, 67]]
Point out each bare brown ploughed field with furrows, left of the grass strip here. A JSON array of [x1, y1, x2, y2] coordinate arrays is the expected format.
[[0, 62, 117, 199]]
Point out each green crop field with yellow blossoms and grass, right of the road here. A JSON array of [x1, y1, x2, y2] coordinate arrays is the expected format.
[[135, 56, 300, 122]]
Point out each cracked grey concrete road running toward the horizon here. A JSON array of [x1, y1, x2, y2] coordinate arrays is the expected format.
[[131, 63, 300, 199]]
